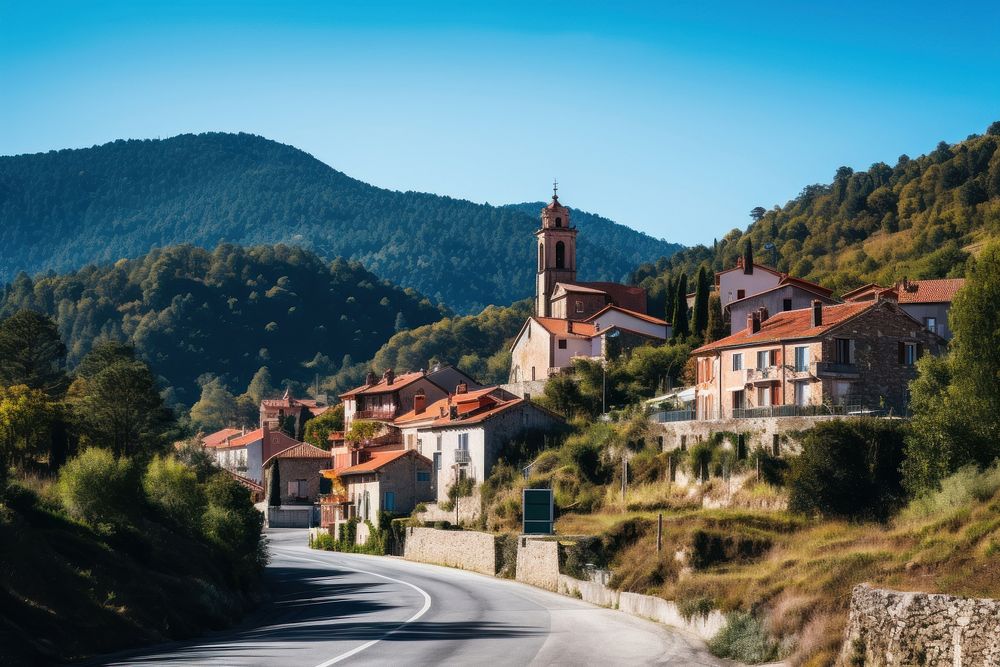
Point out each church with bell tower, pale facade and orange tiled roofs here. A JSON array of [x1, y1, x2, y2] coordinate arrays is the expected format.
[[509, 188, 671, 384]]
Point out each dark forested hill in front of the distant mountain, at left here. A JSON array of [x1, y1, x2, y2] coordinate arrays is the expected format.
[[0, 245, 448, 406]]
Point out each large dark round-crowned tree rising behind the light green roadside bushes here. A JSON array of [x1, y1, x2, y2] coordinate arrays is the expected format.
[[67, 350, 173, 456]]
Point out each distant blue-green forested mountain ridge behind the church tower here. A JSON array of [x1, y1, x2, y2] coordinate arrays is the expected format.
[[0, 133, 680, 312]]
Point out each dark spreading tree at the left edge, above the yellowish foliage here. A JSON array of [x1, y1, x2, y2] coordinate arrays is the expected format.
[[0, 310, 67, 397]]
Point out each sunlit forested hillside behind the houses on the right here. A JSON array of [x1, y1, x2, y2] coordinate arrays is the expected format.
[[631, 122, 1000, 308]]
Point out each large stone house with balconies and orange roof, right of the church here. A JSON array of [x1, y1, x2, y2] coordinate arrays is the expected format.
[[692, 299, 945, 419]]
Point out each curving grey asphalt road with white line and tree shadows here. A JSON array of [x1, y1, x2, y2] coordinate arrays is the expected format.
[[102, 530, 726, 667]]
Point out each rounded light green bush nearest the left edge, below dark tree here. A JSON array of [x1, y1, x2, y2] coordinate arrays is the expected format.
[[57, 447, 139, 526]]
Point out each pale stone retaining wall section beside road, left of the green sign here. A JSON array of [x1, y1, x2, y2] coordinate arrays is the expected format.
[[403, 528, 497, 576]]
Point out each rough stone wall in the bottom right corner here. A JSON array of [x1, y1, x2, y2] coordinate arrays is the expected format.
[[840, 584, 1000, 667]]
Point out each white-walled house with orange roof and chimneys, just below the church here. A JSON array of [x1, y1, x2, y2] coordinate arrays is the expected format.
[[396, 387, 564, 502]]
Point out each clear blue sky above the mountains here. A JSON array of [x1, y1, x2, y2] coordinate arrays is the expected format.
[[0, 0, 1000, 244]]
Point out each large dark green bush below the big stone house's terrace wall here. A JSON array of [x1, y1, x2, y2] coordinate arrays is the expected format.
[[788, 418, 906, 520]]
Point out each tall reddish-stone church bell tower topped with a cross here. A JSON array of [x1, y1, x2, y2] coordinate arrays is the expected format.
[[535, 183, 576, 317]]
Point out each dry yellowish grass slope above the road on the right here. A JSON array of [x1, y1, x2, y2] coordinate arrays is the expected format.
[[557, 468, 1000, 665]]
